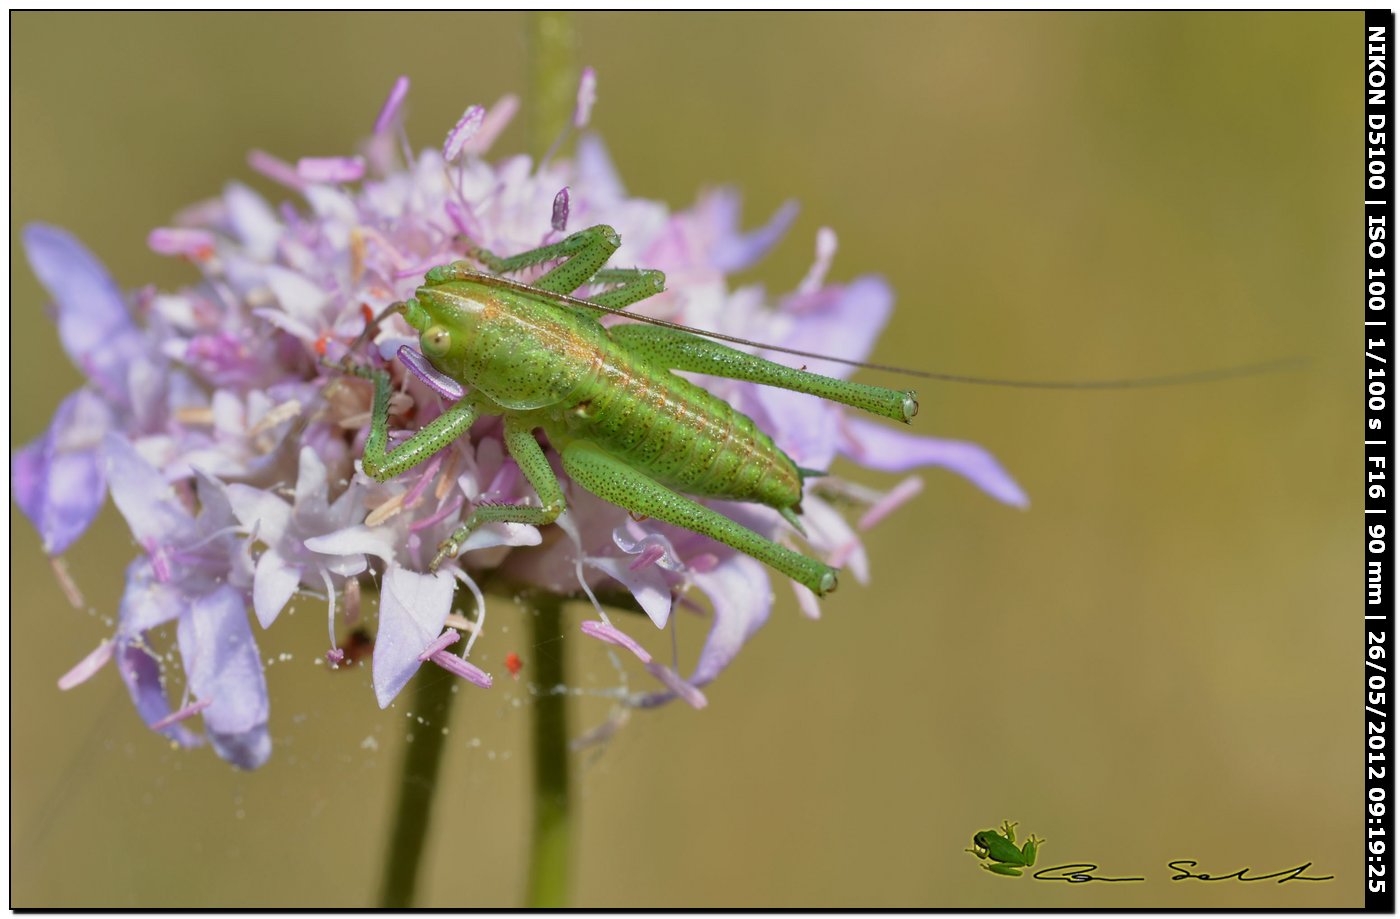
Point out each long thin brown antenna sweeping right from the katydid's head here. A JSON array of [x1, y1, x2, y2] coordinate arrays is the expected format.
[[453, 273, 1305, 389]]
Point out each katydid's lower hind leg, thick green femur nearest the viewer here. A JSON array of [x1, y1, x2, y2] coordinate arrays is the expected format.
[[561, 441, 836, 595]]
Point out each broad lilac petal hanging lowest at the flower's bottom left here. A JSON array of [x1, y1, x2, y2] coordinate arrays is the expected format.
[[176, 586, 272, 769]]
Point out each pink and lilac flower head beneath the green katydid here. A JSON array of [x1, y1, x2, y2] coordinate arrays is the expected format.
[[11, 71, 1026, 768]]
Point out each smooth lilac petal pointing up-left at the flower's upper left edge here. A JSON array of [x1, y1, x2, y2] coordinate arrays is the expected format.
[[24, 223, 136, 378]]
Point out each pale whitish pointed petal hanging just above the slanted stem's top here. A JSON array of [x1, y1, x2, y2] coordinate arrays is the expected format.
[[374, 565, 454, 709]]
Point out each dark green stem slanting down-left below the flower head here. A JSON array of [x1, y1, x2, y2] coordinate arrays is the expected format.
[[379, 665, 458, 909]]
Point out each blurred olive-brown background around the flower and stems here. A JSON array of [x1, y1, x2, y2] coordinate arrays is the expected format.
[[10, 13, 1364, 906]]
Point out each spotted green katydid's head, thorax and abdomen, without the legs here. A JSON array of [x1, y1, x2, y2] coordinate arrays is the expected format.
[[417, 279, 802, 509]]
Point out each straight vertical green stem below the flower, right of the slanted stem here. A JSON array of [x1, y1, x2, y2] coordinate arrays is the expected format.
[[525, 597, 573, 909]]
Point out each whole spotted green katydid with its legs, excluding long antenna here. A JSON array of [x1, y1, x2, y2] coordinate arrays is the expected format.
[[350, 227, 918, 594]]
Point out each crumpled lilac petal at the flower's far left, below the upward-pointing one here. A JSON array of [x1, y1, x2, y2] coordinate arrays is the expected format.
[[10, 389, 111, 555]]
